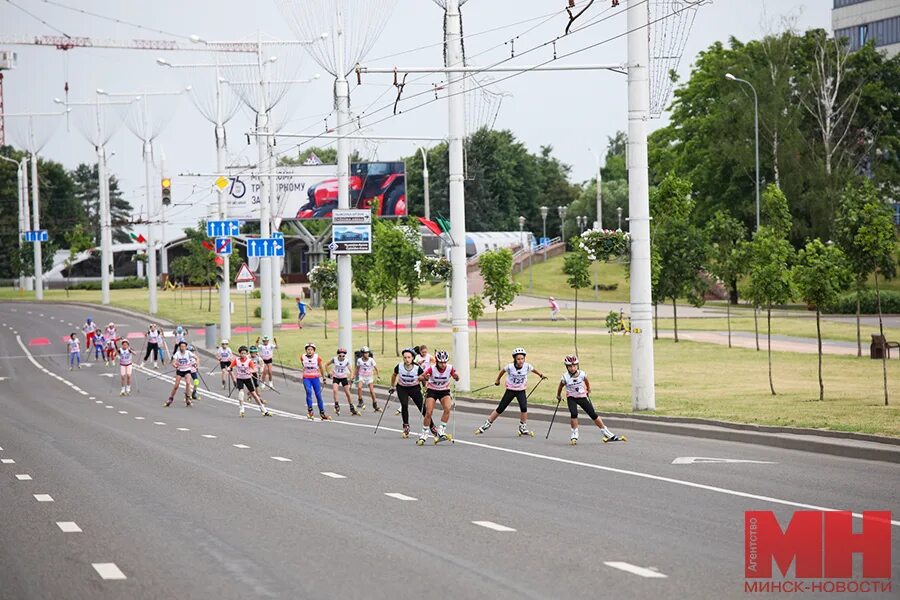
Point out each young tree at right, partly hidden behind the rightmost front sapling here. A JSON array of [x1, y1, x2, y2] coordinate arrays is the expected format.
[[834, 180, 894, 356]]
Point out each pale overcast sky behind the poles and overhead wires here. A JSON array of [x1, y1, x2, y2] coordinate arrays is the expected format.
[[0, 0, 832, 234]]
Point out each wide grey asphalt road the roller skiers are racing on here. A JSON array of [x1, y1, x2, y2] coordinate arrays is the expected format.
[[0, 303, 900, 599]]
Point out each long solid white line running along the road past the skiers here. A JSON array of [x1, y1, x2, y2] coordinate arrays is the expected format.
[[132, 360, 900, 527]]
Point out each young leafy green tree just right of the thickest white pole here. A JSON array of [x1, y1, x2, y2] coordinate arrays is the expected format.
[[650, 173, 706, 343]]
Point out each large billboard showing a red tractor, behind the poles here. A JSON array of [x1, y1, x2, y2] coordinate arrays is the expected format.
[[225, 162, 407, 221]]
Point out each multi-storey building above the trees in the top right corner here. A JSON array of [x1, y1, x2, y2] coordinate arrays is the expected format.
[[831, 0, 900, 56]]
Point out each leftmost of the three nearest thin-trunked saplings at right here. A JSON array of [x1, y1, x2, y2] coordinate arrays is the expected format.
[[744, 226, 794, 396]]
